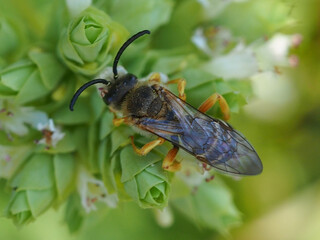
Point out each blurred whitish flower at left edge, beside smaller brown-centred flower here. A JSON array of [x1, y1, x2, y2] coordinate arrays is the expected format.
[[0, 100, 48, 136]]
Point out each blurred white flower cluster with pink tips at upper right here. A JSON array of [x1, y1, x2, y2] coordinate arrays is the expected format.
[[198, 28, 302, 80]]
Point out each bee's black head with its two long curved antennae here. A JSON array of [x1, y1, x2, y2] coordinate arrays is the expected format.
[[69, 30, 150, 111]]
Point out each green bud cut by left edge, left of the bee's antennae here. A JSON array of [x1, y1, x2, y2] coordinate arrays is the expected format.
[[0, 50, 65, 104]]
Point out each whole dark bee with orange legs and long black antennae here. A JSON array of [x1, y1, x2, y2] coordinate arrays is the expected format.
[[70, 30, 263, 175]]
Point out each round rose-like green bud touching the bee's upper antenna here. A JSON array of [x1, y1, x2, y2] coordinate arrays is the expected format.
[[58, 7, 128, 75]]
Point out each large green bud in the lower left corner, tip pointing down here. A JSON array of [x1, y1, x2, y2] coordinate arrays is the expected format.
[[5, 154, 75, 225]]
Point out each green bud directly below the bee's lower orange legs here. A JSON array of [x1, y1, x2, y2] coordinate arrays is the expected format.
[[120, 146, 170, 208]]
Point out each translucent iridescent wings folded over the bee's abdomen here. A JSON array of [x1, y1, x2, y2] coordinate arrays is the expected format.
[[137, 88, 262, 175]]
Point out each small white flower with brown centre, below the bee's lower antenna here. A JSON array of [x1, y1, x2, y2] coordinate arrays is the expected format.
[[37, 119, 65, 147]]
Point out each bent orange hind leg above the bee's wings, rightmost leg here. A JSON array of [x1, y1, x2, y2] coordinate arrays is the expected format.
[[198, 93, 230, 120]]
